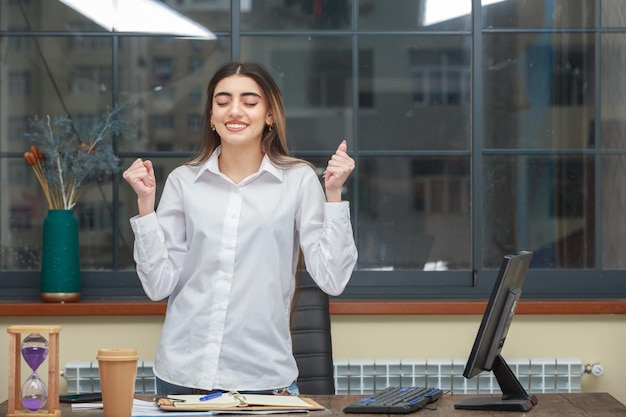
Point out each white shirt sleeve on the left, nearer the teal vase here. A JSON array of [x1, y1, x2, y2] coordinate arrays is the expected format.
[[130, 171, 188, 301]]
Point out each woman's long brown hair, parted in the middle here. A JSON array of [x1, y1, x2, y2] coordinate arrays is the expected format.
[[188, 62, 311, 167]]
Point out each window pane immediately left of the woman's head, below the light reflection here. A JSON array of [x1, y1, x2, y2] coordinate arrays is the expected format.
[[120, 37, 228, 152]]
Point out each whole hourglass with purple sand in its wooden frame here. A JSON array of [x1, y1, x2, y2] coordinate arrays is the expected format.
[[7, 326, 61, 417]]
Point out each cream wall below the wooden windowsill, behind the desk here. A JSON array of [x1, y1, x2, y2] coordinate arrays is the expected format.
[[0, 315, 626, 403]]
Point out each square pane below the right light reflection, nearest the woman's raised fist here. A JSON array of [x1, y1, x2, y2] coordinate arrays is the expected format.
[[358, 36, 471, 150]]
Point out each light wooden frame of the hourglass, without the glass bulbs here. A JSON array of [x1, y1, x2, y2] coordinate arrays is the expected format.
[[7, 325, 61, 417]]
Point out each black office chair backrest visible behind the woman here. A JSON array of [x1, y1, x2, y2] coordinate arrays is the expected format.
[[291, 274, 335, 395]]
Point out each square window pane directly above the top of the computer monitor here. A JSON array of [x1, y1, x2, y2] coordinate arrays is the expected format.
[[483, 155, 595, 268]]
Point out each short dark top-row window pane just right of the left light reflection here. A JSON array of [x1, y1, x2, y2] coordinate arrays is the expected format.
[[244, 0, 352, 30]]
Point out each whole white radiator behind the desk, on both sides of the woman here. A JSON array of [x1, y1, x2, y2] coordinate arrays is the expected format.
[[62, 358, 585, 394]]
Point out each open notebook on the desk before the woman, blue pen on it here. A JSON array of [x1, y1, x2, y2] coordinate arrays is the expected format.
[[157, 392, 325, 412]]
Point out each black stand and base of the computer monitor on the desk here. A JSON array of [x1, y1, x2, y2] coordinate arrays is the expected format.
[[454, 354, 537, 411]]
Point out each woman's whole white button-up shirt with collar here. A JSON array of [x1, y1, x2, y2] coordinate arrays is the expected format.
[[131, 149, 357, 390]]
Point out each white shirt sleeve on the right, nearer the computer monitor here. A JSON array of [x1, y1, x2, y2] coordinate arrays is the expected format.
[[296, 170, 358, 295]]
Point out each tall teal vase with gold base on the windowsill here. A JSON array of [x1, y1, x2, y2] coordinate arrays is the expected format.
[[40, 210, 81, 303]]
